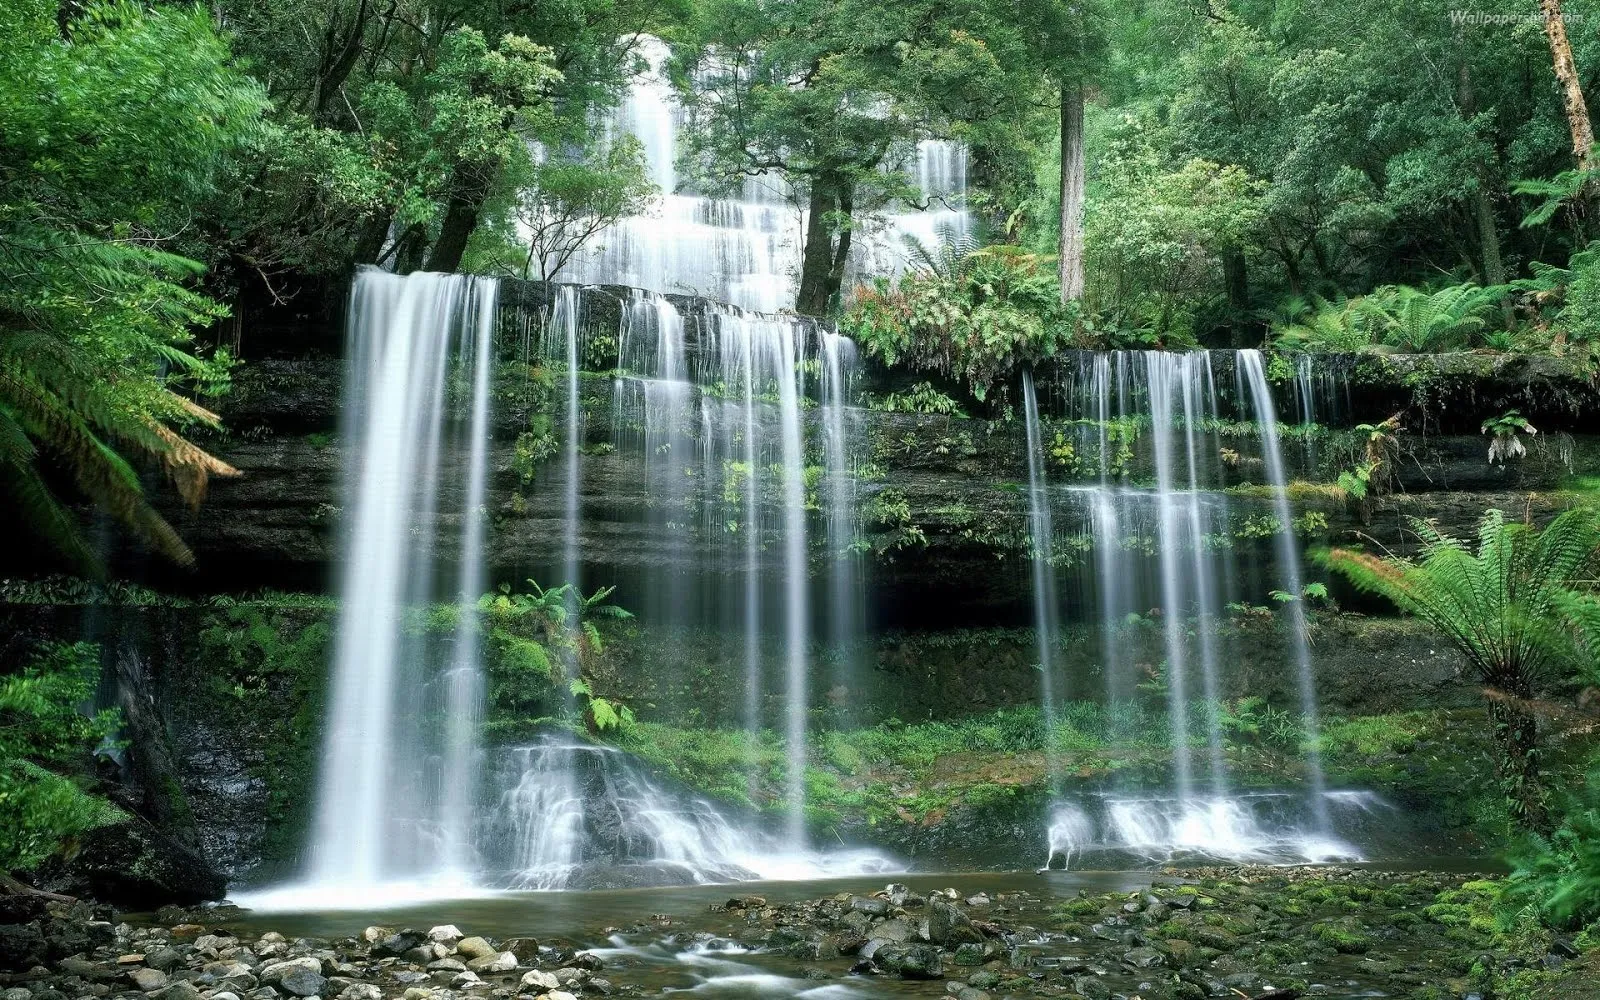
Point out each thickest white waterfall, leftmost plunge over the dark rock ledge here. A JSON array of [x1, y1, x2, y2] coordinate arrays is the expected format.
[[309, 270, 498, 886]]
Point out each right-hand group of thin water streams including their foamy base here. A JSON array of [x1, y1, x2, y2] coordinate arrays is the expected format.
[[1024, 352, 1354, 861]]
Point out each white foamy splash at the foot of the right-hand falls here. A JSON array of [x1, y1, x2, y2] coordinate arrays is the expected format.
[[1045, 792, 1390, 869]]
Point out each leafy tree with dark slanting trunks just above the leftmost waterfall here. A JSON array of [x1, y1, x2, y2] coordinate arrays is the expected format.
[[211, 0, 683, 282]]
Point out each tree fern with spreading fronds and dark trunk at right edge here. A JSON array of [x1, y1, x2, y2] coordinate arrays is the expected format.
[[1326, 509, 1600, 832]]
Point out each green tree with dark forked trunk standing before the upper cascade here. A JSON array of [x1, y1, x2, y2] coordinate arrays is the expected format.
[[680, 0, 1003, 314]]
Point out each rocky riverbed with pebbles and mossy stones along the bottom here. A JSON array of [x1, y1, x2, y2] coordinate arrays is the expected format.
[[0, 867, 1600, 1000]]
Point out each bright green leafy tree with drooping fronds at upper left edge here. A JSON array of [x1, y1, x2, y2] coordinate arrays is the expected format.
[[0, 0, 264, 570]]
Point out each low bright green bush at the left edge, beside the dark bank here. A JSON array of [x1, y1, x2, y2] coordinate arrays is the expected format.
[[0, 643, 122, 872]]
